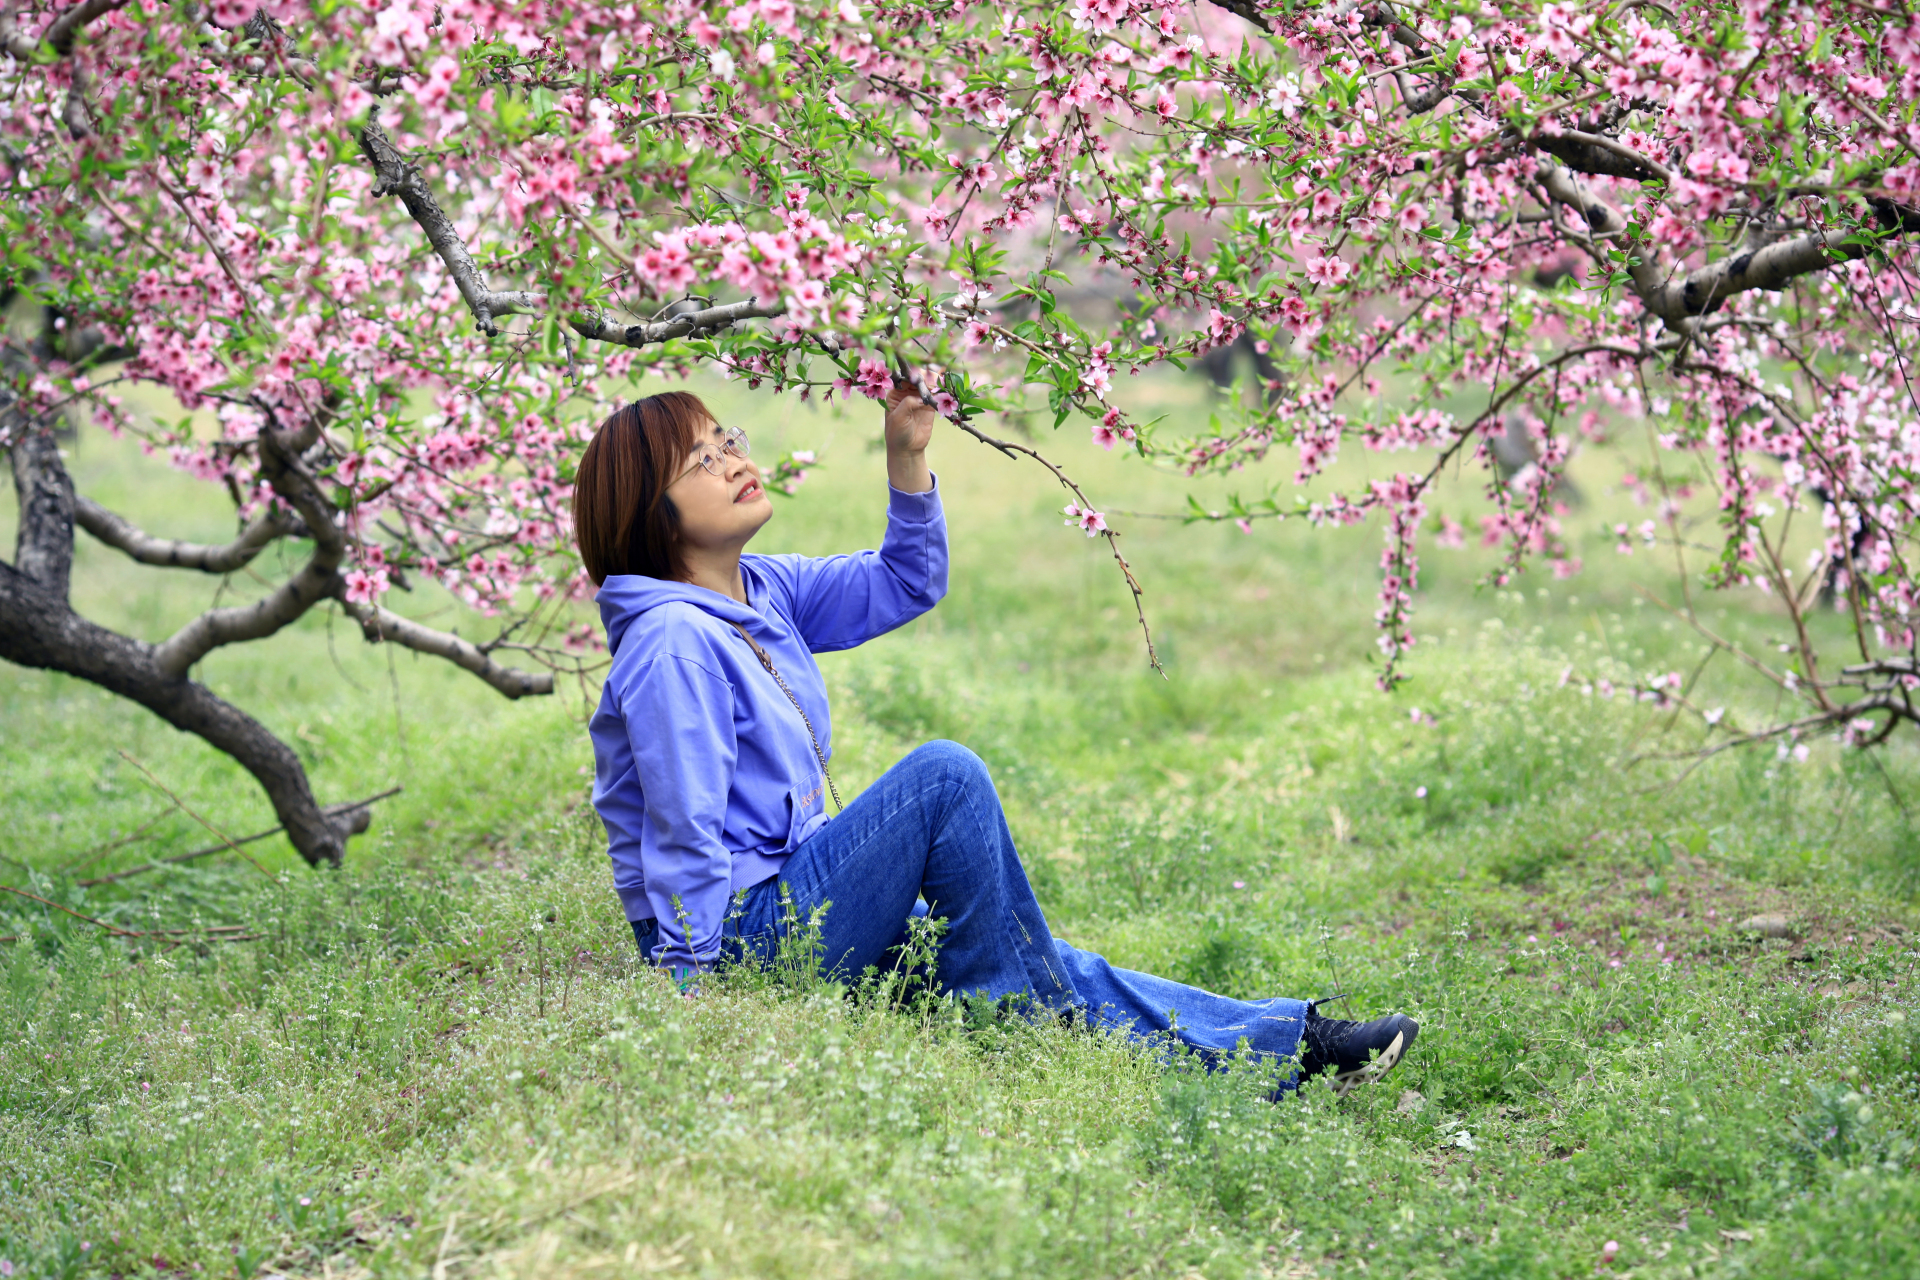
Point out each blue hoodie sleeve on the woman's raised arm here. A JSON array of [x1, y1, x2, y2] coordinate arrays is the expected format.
[[764, 482, 947, 652]]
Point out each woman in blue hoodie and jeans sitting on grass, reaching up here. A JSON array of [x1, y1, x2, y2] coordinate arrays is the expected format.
[[574, 388, 1419, 1090]]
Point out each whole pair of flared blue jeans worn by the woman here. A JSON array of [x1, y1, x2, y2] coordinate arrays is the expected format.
[[634, 743, 1306, 1065]]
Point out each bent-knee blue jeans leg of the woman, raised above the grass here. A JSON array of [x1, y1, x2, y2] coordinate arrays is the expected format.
[[739, 743, 1079, 1007]]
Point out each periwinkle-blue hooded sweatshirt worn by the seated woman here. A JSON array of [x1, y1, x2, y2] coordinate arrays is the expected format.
[[588, 487, 947, 967]]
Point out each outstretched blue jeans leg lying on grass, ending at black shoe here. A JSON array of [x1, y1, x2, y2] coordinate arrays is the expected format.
[[1054, 942, 1308, 1067]]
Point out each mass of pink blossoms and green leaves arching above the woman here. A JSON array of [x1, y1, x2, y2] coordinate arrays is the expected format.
[[11, 0, 1920, 729]]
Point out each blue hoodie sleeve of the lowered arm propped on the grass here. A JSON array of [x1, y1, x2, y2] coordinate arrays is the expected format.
[[620, 654, 737, 969]]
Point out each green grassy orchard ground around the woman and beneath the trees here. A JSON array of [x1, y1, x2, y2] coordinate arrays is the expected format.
[[0, 372, 1920, 1280]]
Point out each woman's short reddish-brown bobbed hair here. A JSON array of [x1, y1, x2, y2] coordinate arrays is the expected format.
[[574, 391, 714, 587]]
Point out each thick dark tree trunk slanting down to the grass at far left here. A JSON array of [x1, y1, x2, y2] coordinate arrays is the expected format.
[[0, 413, 355, 865]]
